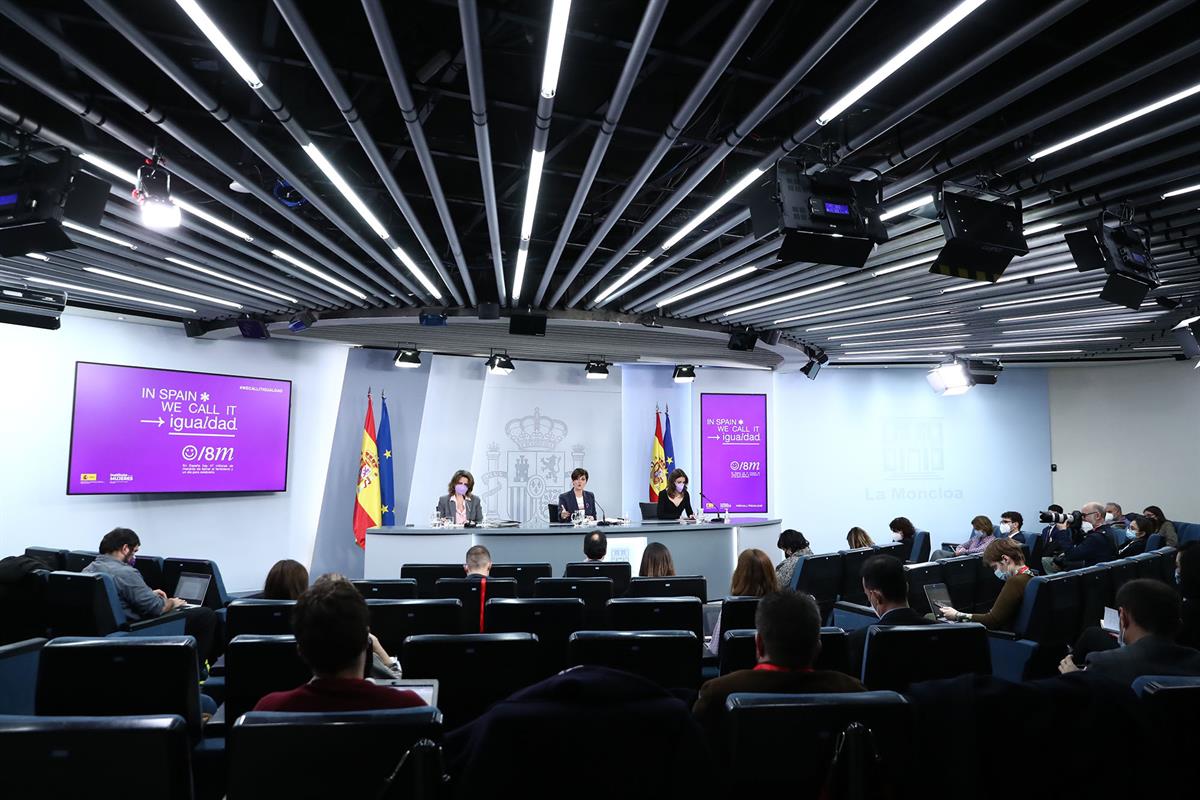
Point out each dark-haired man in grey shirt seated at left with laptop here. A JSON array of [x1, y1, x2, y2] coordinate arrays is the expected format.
[[83, 528, 221, 675]]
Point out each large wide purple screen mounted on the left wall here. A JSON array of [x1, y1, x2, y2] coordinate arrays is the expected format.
[[67, 361, 292, 494]]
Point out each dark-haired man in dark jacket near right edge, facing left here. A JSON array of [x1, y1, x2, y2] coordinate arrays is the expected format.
[[1058, 578, 1200, 685]]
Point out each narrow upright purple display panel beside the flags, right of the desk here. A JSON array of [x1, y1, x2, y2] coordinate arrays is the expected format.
[[700, 393, 767, 513]]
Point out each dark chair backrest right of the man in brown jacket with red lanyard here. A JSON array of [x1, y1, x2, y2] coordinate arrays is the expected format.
[[862, 622, 991, 691]]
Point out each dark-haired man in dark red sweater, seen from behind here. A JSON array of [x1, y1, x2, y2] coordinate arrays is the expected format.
[[254, 575, 425, 711]]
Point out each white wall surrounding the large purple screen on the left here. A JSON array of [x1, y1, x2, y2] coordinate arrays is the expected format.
[[0, 314, 347, 590]]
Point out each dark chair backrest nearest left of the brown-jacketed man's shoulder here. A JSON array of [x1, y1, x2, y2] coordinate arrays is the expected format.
[[566, 631, 701, 688]]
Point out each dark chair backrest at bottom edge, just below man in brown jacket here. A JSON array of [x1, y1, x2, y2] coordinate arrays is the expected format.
[[725, 692, 913, 798]]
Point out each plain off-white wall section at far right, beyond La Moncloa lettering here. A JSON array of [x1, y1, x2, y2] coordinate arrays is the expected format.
[[1051, 361, 1200, 522]]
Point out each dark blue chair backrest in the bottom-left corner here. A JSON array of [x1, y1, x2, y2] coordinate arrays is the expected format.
[[0, 715, 192, 800]]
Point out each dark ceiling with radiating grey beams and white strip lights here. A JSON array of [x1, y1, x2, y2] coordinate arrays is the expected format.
[[0, 0, 1200, 366]]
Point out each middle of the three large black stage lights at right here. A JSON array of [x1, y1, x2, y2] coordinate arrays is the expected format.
[[929, 184, 1030, 283]]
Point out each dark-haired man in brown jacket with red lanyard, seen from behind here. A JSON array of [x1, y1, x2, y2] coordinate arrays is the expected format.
[[692, 590, 865, 733]]
